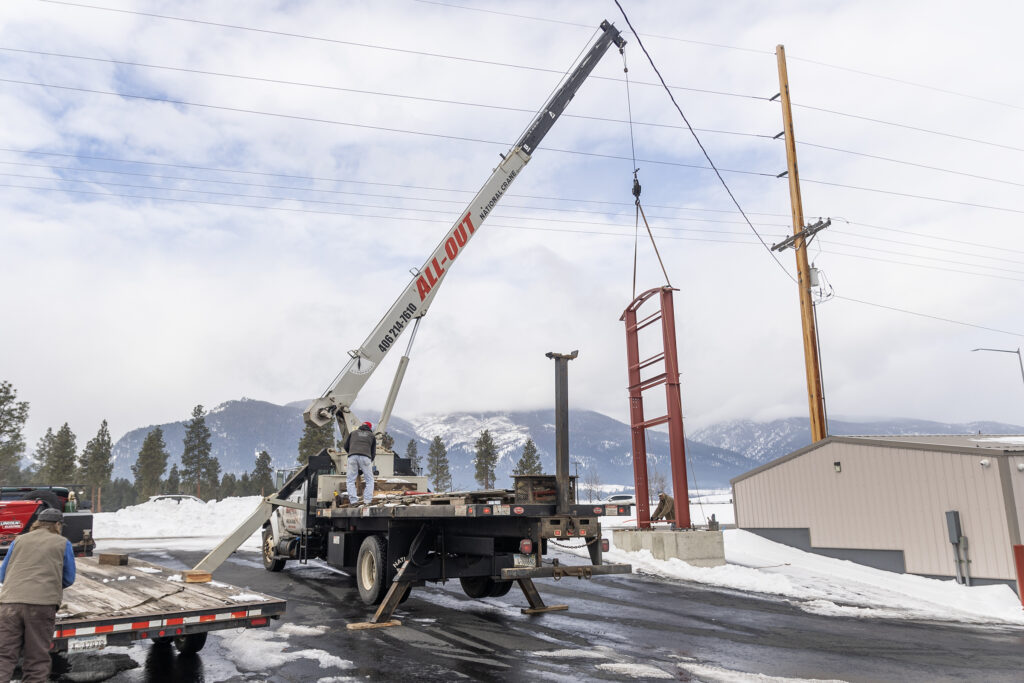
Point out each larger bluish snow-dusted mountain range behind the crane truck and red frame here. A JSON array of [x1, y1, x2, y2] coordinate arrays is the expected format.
[[114, 399, 757, 488]]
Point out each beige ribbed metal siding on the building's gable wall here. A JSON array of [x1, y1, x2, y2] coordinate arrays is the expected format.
[[734, 442, 1024, 579]]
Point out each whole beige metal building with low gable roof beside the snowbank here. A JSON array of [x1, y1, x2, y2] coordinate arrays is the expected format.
[[731, 434, 1024, 595]]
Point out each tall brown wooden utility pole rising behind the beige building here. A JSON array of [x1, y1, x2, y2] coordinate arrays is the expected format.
[[775, 45, 828, 441]]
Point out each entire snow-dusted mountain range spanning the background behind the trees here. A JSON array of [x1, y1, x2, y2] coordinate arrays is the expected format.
[[114, 398, 1024, 488]]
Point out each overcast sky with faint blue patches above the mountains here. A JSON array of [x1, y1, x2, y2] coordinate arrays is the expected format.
[[0, 0, 1024, 449]]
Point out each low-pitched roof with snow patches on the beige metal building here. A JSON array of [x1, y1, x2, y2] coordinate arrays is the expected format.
[[729, 434, 1024, 484]]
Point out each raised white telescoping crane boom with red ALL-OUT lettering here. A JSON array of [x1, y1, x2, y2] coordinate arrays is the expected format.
[[304, 22, 626, 437]]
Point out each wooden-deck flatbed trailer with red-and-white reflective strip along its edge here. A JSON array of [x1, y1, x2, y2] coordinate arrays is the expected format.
[[50, 557, 286, 653]]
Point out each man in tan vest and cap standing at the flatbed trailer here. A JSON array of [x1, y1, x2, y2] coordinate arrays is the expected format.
[[0, 509, 75, 683]]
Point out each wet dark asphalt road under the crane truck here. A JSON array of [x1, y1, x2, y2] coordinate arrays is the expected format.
[[64, 551, 1024, 683]]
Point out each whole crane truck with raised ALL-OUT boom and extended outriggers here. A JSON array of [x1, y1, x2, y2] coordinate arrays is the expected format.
[[196, 22, 632, 628]]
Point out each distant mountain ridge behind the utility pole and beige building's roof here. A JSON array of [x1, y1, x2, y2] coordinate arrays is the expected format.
[[688, 418, 1024, 463]]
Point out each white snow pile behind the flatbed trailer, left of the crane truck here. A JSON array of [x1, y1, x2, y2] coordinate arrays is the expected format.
[[92, 496, 262, 549]]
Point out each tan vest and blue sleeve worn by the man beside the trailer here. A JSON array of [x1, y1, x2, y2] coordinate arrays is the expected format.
[[0, 528, 75, 605]]
